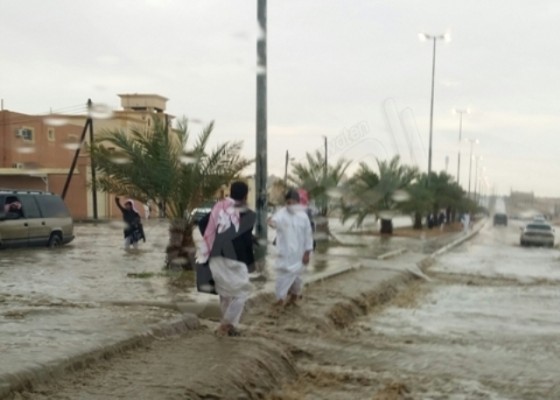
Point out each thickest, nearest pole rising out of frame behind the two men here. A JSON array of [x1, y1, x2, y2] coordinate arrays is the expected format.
[[255, 0, 268, 241]]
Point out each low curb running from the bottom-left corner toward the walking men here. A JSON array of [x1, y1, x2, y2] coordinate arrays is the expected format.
[[0, 314, 200, 398]]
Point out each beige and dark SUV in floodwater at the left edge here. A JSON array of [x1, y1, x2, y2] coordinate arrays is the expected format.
[[0, 189, 74, 248]]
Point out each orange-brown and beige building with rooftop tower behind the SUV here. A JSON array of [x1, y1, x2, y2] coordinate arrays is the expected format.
[[0, 94, 172, 219]]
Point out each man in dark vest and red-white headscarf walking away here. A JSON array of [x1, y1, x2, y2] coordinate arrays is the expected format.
[[198, 182, 256, 336]]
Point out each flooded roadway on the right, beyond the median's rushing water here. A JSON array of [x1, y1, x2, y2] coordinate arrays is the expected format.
[[278, 222, 560, 399]]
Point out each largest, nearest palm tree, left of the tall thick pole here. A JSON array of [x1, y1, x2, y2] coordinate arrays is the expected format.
[[90, 118, 251, 268]]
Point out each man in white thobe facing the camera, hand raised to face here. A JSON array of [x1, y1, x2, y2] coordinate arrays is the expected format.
[[268, 189, 313, 306]]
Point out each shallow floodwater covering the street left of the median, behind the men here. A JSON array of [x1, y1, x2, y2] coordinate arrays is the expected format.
[[0, 216, 436, 388]]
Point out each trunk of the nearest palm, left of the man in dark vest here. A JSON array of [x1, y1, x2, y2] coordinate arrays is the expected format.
[[165, 219, 196, 270]]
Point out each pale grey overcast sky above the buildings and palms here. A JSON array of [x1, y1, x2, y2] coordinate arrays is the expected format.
[[0, 0, 560, 197]]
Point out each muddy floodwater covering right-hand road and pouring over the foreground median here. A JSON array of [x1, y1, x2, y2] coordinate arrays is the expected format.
[[12, 220, 560, 400]]
